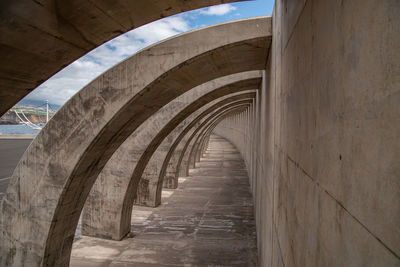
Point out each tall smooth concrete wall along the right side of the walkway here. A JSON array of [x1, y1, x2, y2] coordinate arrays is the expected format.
[[215, 0, 400, 266]]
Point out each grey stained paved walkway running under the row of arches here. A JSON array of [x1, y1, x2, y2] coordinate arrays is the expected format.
[[71, 135, 257, 267]]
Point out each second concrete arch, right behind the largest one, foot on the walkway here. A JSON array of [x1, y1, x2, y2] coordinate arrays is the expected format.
[[82, 71, 261, 240]]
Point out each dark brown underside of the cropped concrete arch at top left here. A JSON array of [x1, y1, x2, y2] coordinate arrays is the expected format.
[[0, 0, 247, 116]]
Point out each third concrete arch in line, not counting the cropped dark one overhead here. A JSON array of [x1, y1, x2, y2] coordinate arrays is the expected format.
[[134, 102, 250, 207]]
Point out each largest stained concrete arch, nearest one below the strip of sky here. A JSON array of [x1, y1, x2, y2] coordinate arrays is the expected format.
[[1, 17, 271, 266]]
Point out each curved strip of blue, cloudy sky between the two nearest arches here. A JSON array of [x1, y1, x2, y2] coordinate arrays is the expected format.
[[23, 0, 273, 106]]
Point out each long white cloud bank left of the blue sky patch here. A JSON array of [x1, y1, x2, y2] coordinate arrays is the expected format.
[[26, 15, 190, 105]]
